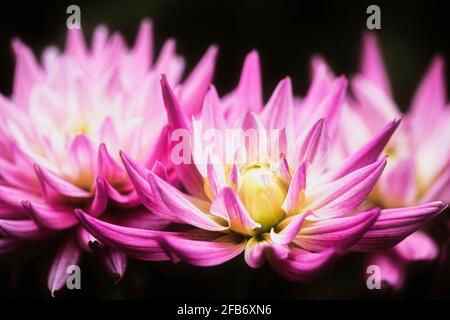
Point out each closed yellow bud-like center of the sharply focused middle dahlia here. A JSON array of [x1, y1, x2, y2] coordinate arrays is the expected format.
[[239, 164, 287, 232]]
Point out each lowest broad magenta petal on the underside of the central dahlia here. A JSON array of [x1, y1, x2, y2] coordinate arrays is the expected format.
[[268, 248, 334, 282]]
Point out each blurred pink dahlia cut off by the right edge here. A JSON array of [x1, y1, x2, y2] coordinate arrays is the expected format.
[[337, 34, 450, 288]]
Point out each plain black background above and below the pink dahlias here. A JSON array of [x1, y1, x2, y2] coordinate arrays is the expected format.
[[0, 0, 450, 298]]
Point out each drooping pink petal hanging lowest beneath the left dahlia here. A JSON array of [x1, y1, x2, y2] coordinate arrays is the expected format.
[[47, 237, 81, 297]]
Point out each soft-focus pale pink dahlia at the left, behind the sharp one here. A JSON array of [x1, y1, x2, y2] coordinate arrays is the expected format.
[[0, 21, 216, 294]]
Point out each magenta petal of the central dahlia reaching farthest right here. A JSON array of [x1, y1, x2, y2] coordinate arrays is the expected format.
[[352, 201, 447, 251]]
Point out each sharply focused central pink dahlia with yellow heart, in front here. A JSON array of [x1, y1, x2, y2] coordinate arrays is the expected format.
[[76, 52, 445, 281]]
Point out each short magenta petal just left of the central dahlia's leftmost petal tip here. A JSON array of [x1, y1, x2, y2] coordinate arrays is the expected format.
[[22, 201, 77, 230]]
